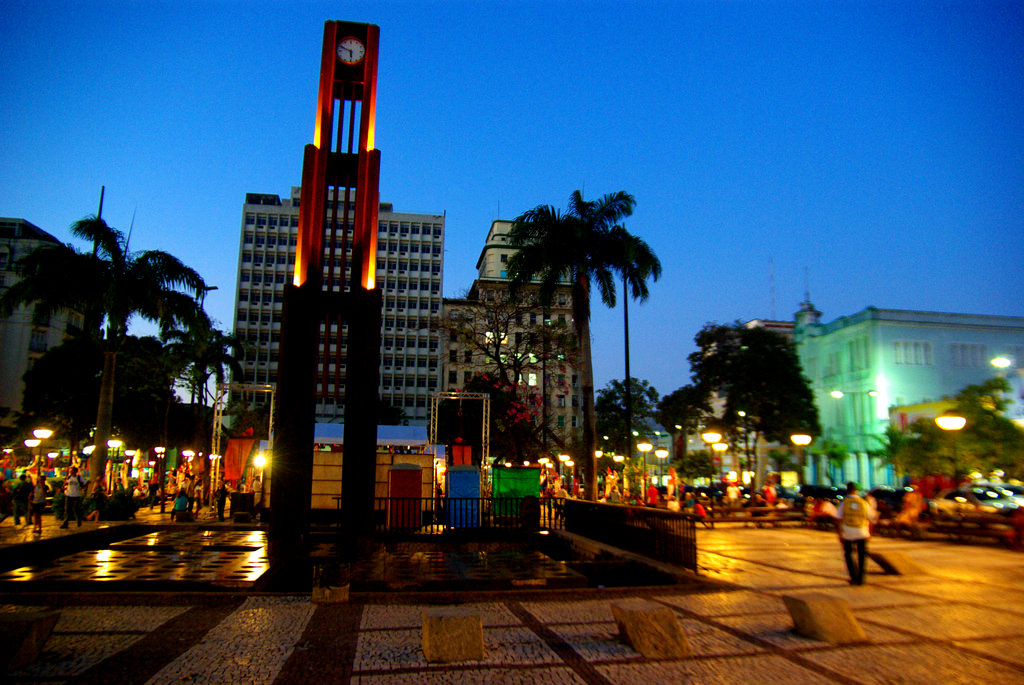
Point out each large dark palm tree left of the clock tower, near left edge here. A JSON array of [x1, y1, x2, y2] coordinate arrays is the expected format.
[[0, 216, 205, 489]]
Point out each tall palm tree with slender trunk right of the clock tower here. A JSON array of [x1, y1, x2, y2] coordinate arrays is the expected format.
[[508, 190, 662, 499]]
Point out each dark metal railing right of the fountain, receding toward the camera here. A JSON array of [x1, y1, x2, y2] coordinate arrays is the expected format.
[[564, 500, 697, 572]]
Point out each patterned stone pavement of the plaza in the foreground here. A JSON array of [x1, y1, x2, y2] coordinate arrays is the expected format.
[[0, 526, 1024, 685]]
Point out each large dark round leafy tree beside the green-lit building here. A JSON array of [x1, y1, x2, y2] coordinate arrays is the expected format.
[[689, 323, 821, 485]]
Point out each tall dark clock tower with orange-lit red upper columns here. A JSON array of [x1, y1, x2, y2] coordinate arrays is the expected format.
[[269, 22, 381, 555]]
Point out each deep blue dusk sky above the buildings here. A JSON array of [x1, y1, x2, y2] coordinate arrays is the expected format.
[[0, 0, 1024, 393]]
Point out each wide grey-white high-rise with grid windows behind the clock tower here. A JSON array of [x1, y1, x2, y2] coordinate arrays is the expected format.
[[233, 187, 444, 425]]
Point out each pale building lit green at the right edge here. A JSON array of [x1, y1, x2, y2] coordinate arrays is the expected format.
[[794, 301, 1024, 486]]
